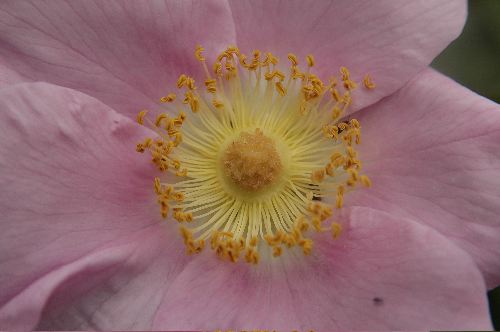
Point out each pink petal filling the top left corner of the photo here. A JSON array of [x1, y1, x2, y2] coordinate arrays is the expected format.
[[0, 1, 234, 117]]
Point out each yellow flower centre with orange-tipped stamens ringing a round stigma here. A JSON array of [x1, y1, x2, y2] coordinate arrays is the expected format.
[[136, 46, 375, 264]]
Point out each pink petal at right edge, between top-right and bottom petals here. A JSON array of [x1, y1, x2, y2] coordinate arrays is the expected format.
[[347, 70, 500, 287]]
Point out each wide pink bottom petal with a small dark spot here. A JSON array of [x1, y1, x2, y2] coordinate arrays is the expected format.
[[153, 208, 491, 331]]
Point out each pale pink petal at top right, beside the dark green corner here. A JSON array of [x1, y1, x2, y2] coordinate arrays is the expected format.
[[230, 0, 466, 110]]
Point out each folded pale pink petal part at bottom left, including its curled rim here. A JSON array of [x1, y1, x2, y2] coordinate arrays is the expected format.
[[0, 225, 189, 330]]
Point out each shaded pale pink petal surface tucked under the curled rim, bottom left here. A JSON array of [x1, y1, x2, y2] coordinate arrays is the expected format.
[[36, 227, 190, 330]]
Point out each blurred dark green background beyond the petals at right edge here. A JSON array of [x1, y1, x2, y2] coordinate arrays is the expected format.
[[432, 0, 500, 330]]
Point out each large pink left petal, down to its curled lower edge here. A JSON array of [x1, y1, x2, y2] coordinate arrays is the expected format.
[[0, 83, 185, 329]]
